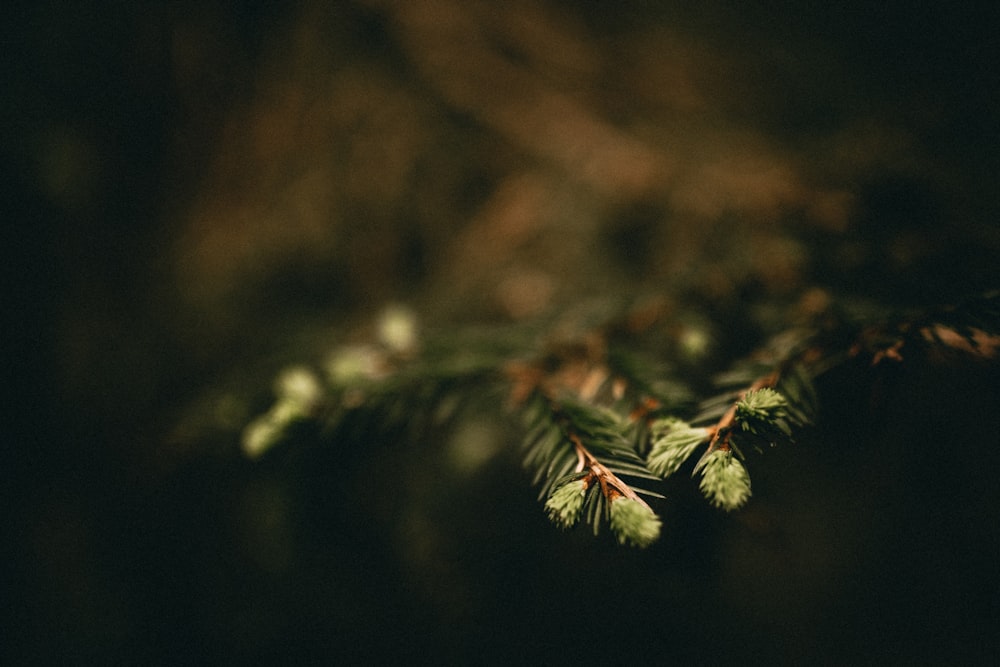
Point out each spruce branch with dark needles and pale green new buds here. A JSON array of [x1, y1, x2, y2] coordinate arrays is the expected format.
[[243, 295, 1000, 547]]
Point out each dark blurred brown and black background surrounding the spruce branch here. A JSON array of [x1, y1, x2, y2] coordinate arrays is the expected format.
[[0, 0, 1000, 664]]
